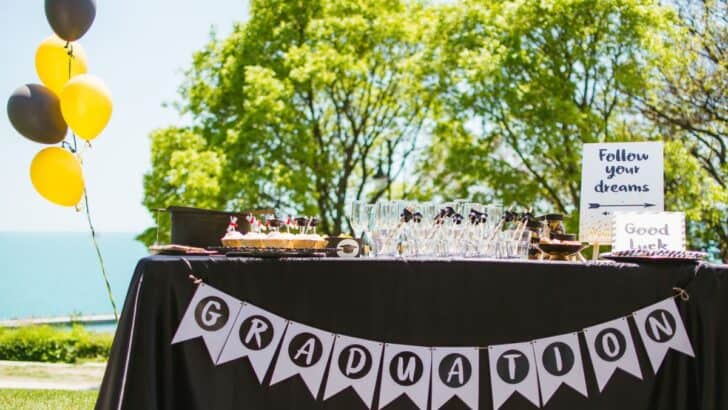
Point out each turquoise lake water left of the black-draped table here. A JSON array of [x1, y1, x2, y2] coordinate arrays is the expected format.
[[0, 232, 147, 320]]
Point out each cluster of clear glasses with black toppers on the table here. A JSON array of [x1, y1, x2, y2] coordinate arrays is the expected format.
[[349, 200, 531, 259]]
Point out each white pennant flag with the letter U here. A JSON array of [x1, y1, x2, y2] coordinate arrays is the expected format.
[[379, 344, 432, 409]]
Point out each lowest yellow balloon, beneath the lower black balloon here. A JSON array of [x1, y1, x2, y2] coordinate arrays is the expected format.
[[30, 147, 84, 206]]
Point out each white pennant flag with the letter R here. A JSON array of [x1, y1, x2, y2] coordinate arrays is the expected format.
[[217, 303, 287, 383]]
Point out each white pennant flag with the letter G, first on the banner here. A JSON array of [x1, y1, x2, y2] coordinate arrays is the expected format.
[[172, 283, 243, 363]]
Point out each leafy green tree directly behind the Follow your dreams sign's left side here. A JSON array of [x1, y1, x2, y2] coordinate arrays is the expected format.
[[420, 0, 667, 223]]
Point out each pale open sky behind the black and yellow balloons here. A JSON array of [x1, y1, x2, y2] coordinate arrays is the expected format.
[[0, 0, 248, 232]]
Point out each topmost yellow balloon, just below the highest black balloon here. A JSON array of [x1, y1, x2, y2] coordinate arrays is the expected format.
[[35, 36, 88, 95]]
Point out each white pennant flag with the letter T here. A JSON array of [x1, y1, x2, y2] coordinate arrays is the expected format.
[[488, 342, 541, 410]]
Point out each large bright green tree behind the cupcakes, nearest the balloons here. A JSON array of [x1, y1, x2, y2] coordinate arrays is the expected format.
[[145, 0, 436, 243]]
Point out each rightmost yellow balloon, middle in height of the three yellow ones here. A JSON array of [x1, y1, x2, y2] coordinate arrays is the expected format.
[[61, 74, 113, 141]]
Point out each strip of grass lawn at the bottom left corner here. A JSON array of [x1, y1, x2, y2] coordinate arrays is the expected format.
[[0, 389, 99, 410]]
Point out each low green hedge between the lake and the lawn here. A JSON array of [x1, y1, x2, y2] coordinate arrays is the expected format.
[[0, 325, 113, 363]]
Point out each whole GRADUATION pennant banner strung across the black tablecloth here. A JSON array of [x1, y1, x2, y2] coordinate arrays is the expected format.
[[172, 283, 695, 410]]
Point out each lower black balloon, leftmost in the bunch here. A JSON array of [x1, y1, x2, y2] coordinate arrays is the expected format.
[[8, 84, 68, 144]]
